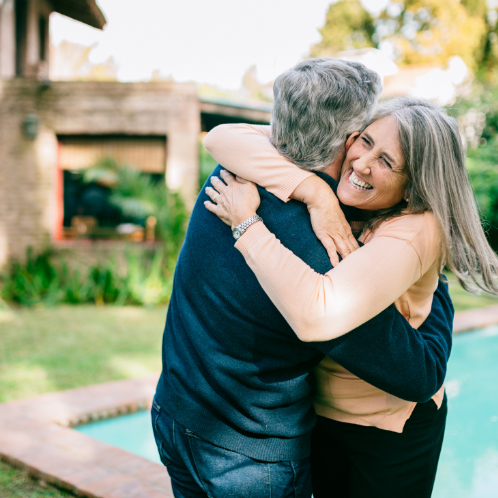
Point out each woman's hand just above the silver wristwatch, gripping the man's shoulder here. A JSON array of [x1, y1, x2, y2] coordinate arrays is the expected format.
[[204, 170, 261, 228]]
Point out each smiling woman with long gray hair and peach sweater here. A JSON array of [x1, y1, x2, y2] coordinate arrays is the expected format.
[[205, 98, 498, 498]]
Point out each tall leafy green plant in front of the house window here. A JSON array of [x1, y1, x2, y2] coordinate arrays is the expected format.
[[83, 157, 188, 254]]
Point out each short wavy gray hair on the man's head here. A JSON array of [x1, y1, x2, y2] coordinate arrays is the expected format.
[[270, 59, 382, 171]]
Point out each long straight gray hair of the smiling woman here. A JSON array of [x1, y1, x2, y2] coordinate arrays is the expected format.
[[369, 98, 498, 294]]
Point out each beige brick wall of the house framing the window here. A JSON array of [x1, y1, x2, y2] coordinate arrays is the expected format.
[[0, 79, 200, 266]]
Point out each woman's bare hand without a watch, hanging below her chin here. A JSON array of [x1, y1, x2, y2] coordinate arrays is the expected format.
[[291, 175, 360, 267]]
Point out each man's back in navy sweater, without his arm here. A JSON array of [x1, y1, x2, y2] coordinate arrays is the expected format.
[[156, 167, 342, 461]]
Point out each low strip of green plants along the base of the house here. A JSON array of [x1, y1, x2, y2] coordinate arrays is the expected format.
[[0, 247, 176, 306]]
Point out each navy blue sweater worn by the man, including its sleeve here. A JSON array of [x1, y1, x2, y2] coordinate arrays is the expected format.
[[156, 167, 453, 462]]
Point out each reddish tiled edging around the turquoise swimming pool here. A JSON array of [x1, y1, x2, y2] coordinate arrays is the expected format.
[[0, 306, 498, 498]]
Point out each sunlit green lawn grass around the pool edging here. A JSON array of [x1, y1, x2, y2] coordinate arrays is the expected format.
[[0, 275, 498, 498]]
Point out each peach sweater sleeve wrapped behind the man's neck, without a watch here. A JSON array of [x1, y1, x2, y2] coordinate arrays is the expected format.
[[204, 124, 313, 202]]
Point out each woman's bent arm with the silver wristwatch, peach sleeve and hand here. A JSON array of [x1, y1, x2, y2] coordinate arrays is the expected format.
[[206, 174, 430, 342]]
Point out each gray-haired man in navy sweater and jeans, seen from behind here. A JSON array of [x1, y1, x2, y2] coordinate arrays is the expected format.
[[152, 59, 453, 498]]
